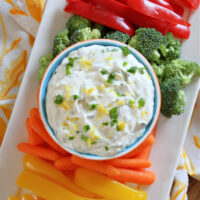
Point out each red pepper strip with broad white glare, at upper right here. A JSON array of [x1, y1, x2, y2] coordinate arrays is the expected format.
[[128, 0, 187, 25]]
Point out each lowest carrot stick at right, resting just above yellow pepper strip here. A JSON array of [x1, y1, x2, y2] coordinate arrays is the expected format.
[[111, 169, 156, 185]]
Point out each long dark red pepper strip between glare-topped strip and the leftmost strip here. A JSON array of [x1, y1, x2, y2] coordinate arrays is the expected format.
[[85, 0, 170, 34]]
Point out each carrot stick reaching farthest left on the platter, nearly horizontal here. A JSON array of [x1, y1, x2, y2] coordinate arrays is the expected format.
[[17, 143, 60, 161]]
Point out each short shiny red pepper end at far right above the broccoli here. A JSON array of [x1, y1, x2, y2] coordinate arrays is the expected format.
[[169, 24, 190, 39]]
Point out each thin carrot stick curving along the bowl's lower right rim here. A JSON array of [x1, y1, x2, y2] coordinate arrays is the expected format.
[[121, 135, 154, 158]]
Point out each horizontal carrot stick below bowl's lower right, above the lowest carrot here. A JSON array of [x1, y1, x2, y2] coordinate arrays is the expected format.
[[108, 158, 151, 168]]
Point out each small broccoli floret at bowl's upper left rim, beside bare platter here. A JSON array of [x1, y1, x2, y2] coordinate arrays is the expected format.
[[53, 29, 70, 56]]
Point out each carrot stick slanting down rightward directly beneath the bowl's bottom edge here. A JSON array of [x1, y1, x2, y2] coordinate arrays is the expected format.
[[72, 156, 119, 176]]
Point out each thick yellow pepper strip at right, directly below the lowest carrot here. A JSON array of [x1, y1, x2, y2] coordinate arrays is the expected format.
[[75, 168, 147, 200]]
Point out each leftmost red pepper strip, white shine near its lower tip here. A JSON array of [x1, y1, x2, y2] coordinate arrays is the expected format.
[[65, 0, 134, 36]]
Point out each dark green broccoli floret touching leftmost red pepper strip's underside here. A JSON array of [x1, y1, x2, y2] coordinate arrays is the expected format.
[[66, 15, 92, 36]]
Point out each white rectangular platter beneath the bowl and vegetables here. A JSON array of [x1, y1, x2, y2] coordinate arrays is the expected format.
[[0, 0, 200, 200]]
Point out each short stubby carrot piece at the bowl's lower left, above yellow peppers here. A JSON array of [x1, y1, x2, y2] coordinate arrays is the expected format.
[[54, 156, 78, 170]]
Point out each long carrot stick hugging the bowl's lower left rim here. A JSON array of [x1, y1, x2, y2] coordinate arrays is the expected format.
[[29, 114, 68, 156]]
